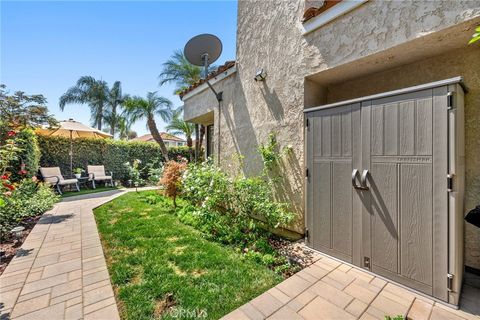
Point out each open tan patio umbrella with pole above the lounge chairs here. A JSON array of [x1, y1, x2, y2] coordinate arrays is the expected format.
[[35, 119, 112, 175]]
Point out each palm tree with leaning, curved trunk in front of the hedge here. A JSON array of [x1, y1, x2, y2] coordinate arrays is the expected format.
[[125, 92, 172, 161]]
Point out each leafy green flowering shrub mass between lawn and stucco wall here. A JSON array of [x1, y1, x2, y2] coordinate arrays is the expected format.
[[176, 160, 294, 274]]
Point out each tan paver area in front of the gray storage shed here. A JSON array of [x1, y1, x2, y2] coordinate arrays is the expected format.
[[223, 254, 480, 320]]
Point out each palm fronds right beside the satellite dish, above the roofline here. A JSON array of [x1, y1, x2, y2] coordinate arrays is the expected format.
[[159, 50, 202, 94]]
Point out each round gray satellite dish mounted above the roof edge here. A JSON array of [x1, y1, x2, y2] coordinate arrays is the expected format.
[[183, 33, 222, 66]]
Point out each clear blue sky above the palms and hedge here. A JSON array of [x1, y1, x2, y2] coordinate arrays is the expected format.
[[0, 0, 237, 135]]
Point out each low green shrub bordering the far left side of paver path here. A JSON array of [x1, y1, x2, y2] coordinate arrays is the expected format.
[[0, 179, 59, 239]]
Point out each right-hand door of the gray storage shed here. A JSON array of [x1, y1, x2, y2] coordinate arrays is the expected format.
[[360, 89, 448, 298]]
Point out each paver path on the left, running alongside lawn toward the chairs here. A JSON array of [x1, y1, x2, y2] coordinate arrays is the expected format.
[[0, 190, 134, 320]]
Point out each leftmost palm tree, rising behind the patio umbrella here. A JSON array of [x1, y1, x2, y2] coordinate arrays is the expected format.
[[59, 76, 109, 130]]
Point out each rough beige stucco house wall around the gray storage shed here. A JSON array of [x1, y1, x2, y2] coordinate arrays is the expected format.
[[185, 0, 480, 268]]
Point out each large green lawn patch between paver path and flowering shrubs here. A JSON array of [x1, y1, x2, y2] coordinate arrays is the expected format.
[[95, 191, 282, 319]]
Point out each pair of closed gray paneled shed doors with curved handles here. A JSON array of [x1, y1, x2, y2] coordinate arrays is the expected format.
[[306, 86, 448, 300]]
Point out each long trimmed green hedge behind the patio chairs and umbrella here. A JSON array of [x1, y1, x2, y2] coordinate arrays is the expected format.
[[37, 135, 193, 183]]
